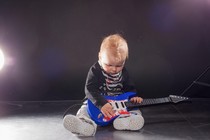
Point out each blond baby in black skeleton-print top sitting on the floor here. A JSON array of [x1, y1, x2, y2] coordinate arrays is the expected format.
[[63, 34, 144, 136]]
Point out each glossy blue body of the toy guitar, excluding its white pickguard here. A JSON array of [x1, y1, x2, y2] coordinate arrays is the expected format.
[[87, 92, 136, 126]]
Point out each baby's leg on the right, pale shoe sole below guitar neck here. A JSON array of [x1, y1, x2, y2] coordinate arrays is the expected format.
[[113, 109, 144, 130]]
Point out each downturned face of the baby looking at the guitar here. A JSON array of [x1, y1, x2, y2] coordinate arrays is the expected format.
[[99, 53, 125, 74]]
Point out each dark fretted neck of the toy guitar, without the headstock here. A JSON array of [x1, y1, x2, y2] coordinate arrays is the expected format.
[[125, 97, 171, 108]]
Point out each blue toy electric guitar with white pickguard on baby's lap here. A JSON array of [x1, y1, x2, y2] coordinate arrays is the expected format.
[[87, 92, 189, 126]]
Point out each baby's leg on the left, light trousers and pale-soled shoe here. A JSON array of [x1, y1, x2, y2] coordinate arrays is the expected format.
[[63, 105, 97, 136]]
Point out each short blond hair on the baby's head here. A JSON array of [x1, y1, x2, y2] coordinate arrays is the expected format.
[[100, 34, 128, 62]]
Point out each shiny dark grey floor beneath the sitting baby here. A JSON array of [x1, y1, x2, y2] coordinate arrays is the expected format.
[[0, 100, 210, 140]]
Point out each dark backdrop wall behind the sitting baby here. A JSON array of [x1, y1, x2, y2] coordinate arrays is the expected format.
[[0, 0, 210, 101]]
